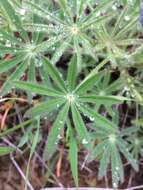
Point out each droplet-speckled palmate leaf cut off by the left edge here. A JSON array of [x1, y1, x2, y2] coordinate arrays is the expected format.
[[0, 27, 57, 95]]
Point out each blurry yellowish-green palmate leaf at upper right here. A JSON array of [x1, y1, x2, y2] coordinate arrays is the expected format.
[[95, 2, 138, 64]]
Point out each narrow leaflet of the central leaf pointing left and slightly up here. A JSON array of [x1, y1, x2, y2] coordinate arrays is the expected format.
[[12, 81, 64, 97]]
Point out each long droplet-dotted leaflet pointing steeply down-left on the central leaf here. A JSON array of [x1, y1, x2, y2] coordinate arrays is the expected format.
[[44, 103, 69, 160]]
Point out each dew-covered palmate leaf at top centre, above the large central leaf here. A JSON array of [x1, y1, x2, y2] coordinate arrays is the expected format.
[[20, 0, 112, 66]]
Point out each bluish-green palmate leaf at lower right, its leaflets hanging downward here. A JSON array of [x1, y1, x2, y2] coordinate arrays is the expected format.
[[89, 116, 138, 188]]
